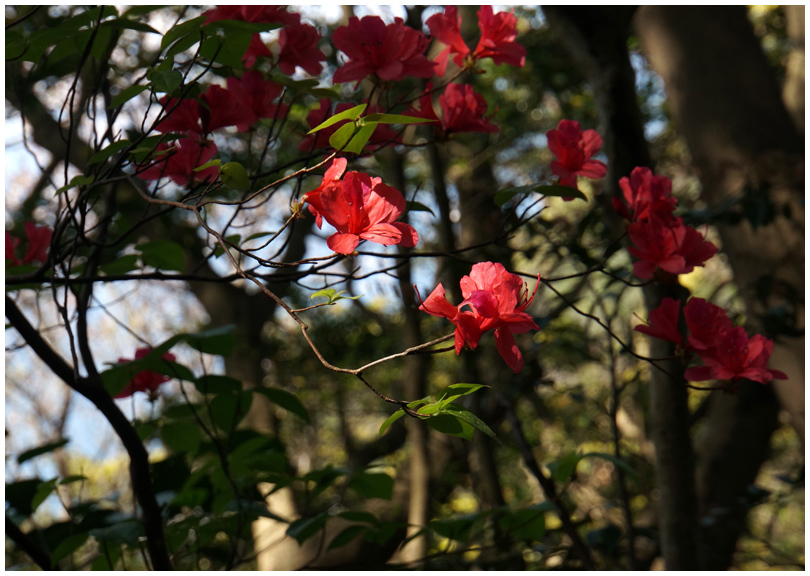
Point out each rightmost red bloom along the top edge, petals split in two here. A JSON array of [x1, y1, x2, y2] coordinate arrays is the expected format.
[[426, 6, 526, 76]]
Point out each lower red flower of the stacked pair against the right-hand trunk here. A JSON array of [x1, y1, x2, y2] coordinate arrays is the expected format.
[[627, 218, 717, 279]]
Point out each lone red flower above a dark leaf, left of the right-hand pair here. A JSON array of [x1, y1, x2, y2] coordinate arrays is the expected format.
[[546, 120, 607, 200]]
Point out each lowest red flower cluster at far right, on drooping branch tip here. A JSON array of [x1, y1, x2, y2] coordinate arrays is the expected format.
[[635, 298, 787, 384]]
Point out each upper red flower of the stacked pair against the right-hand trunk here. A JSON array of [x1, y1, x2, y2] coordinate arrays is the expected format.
[[613, 168, 678, 221]]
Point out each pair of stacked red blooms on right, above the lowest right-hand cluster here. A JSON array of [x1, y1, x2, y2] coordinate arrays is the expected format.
[[613, 168, 717, 279]]
